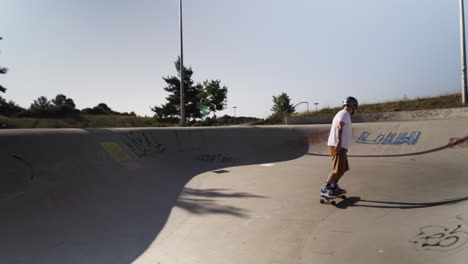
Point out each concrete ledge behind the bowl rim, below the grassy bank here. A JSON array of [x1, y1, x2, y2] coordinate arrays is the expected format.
[[286, 107, 468, 125]]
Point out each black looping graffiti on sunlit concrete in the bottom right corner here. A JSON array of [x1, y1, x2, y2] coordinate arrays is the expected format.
[[409, 224, 468, 252]]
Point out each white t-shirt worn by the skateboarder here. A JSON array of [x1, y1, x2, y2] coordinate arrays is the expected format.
[[328, 109, 353, 149]]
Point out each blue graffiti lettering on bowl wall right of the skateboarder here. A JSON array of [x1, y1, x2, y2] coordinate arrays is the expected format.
[[356, 131, 421, 145]]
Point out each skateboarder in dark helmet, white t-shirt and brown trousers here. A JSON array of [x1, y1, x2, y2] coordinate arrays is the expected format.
[[320, 97, 358, 198]]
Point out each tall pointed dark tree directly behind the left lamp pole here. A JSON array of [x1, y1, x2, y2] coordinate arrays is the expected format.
[[151, 57, 203, 121]]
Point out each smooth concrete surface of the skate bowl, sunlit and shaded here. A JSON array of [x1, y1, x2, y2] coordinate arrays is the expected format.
[[0, 118, 468, 264]]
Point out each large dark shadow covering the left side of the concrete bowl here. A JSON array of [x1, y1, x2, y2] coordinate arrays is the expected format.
[[0, 128, 308, 264]]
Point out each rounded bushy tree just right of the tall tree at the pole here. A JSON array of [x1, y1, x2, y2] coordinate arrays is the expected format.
[[198, 80, 227, 115]]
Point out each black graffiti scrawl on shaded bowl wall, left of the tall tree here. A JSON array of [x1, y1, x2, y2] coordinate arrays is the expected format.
[[123, 132, 166, 158]]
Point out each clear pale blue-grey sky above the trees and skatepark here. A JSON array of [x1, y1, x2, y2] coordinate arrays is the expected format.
[[0, 0, 461, 118]]
